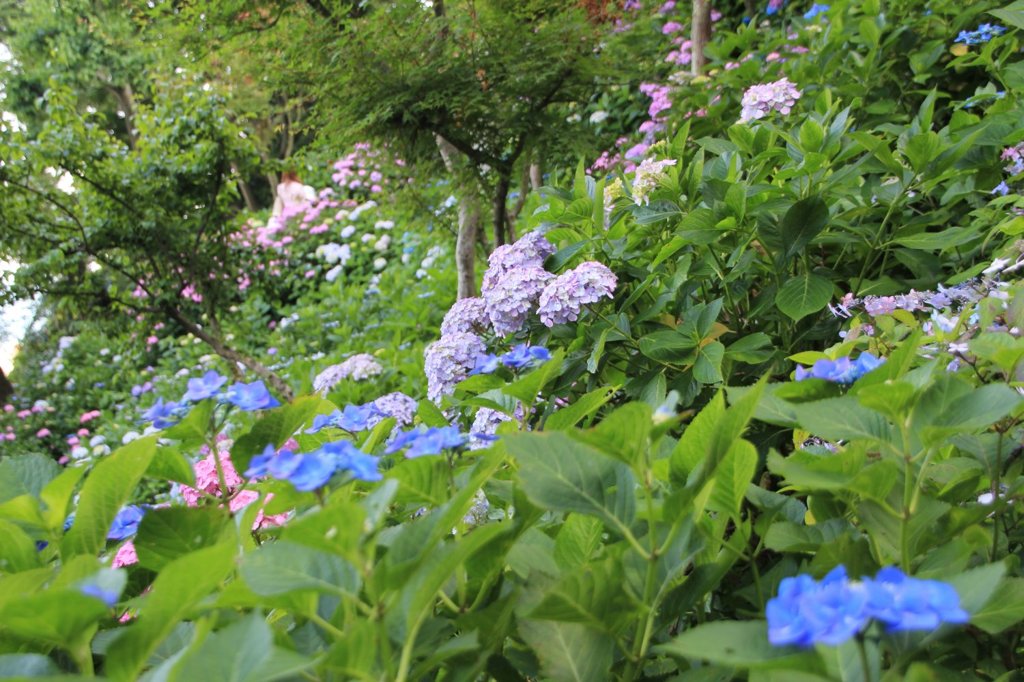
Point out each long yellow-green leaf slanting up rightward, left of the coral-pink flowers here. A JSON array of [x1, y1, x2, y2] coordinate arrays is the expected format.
[[61, 435, 157, 556]]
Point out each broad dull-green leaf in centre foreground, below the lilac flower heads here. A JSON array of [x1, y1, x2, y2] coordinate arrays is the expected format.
[[505, 432, 636, 529]]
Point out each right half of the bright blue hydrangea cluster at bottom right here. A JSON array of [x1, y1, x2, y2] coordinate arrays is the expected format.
[[864, 567, 971, 632]]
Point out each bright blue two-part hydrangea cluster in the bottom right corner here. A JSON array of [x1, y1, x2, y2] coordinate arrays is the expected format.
[[765, 566, 970, 647]]
